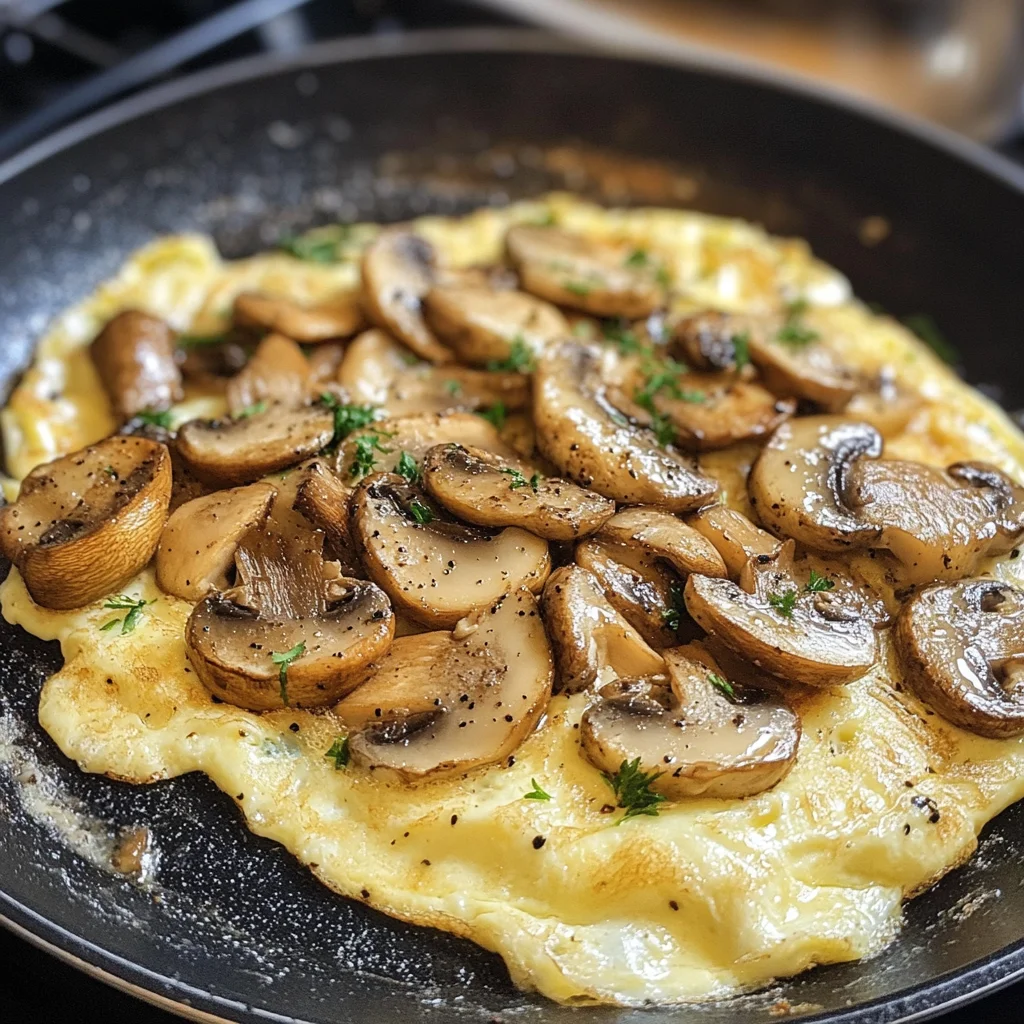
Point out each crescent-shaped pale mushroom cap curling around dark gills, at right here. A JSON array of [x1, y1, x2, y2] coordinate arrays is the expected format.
[[746, 416, 882, 551]]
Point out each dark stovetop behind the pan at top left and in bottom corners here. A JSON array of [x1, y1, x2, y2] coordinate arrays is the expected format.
[[0, 0, 1024, 1024]]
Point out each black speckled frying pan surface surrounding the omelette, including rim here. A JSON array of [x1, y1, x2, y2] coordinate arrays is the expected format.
[[0, 30, 1024, 1024]]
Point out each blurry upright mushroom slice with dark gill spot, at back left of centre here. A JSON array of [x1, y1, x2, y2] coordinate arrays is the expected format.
[[362, 227, 452, 362]]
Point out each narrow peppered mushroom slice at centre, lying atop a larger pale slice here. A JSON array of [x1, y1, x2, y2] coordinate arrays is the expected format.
[[423, 443, 615, 541]]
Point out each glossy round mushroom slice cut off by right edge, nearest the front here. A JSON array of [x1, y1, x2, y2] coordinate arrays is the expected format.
[[893, 580, 1024, 739]]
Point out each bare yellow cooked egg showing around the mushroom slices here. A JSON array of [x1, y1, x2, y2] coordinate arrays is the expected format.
[[0, 197, 1024, 1004]]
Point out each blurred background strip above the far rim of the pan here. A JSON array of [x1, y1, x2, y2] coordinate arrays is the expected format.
[[0, 0, 1024, 165]]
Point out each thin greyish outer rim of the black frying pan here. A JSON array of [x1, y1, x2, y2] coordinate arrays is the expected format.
[[0, 28, 1024, 1024]]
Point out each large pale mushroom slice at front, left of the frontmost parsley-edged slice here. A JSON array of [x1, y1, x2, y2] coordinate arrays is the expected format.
[[336, 590, 554, 778]]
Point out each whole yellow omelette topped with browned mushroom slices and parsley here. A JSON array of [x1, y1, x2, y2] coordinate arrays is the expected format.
[[0, 195, 1024, 1006]]
